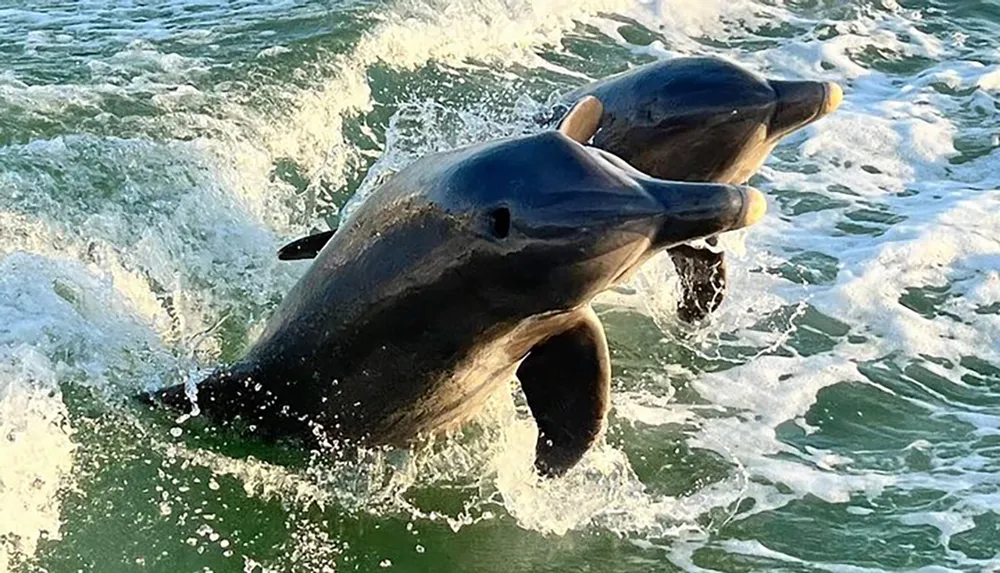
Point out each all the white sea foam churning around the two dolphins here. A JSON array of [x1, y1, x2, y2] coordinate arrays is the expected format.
[[0, 0, 1000, 571]]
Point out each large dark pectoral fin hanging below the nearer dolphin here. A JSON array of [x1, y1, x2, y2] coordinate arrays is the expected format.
[[517, 308, 611, 476]]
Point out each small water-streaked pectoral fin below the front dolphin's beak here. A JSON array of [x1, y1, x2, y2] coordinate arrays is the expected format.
[[668, 237, 726, 323]]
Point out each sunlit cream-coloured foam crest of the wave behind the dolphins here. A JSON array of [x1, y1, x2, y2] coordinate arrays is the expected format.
[[266, 0, 628, 211]]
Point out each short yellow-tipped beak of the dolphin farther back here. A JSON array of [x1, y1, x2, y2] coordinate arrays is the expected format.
[[768, 80, 844, 139]]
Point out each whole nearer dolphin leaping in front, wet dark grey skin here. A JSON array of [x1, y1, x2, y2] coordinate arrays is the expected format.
[[146, 127, 765, 475]]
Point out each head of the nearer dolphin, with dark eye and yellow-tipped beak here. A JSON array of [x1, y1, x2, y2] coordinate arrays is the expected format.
[[418, 131, 765, 314]]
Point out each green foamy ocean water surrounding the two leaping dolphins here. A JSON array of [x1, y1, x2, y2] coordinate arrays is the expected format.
[[0, 0, 1000, 573]]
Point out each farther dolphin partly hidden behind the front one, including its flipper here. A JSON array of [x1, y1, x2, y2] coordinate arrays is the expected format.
[[550, 58, 843, 322]]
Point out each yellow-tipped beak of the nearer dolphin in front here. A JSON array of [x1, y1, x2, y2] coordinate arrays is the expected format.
[[637, 179, 767, 248]]
